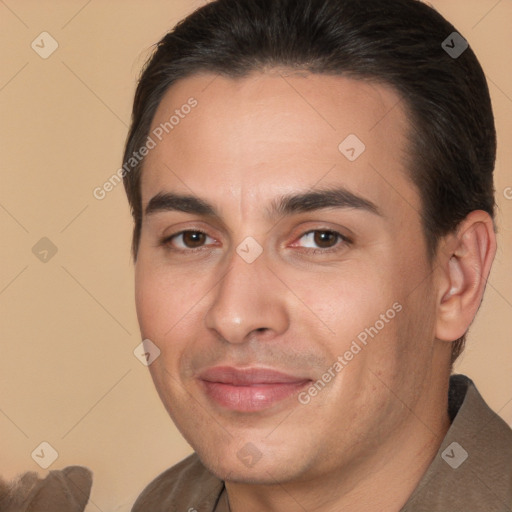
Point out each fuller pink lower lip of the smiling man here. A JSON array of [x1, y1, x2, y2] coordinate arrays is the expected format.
[[201, 380, 310, 412]]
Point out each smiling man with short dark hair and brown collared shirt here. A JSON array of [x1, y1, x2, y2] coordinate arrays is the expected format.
[[123, 0, 512, 512]]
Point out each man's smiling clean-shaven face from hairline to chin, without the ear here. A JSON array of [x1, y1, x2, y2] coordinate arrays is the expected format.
[[136, 71, 446, 483]]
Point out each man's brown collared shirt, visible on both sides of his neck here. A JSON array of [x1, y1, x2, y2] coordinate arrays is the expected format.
[[132, 375, 512, 512]]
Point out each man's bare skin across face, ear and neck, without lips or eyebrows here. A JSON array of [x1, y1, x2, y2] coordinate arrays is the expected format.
[[136, 70, 495, 512]]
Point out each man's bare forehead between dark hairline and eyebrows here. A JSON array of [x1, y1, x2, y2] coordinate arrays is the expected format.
[[142, 70, 419, 218]]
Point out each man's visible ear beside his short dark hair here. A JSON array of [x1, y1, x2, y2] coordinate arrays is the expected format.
[[436, 210, 496, 341]]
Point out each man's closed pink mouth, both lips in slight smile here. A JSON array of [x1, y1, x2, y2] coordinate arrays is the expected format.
[[199, 366, 311, 412]]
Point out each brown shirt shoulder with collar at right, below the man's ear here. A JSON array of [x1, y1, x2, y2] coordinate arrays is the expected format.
[[401, 375, 512, 512]]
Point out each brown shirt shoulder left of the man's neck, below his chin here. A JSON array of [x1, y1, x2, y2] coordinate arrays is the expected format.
[[132, 453, 224, 512]]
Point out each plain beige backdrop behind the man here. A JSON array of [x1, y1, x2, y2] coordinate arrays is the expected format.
[[0, 0, 512, 512]]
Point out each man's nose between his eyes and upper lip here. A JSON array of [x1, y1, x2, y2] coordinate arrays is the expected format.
[[205, 248, 289, 344]]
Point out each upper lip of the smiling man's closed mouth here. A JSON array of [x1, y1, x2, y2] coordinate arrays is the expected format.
[[199, 366, 311, 386]]
